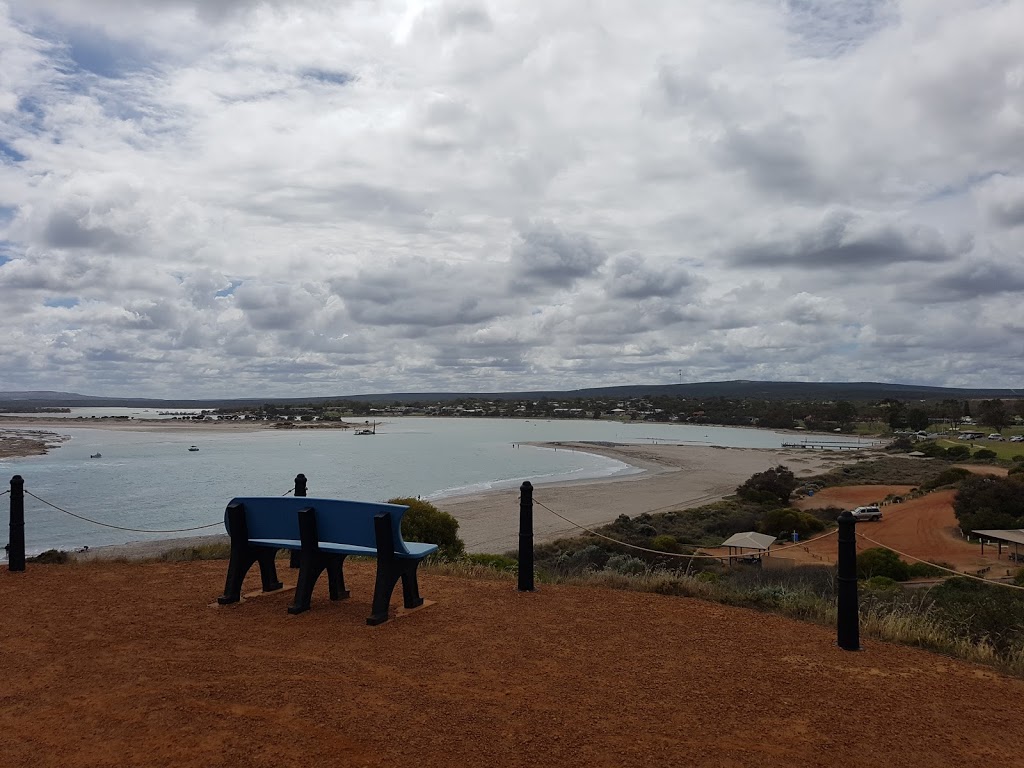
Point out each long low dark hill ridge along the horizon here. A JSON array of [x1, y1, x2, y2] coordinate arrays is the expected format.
[[0, 380, 1021, 410]]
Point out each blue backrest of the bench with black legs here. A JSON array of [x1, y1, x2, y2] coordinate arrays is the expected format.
[[224, 496, 409, 554]]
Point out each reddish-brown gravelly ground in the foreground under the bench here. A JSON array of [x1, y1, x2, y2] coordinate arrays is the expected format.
[[0, 561, 1024, 768]]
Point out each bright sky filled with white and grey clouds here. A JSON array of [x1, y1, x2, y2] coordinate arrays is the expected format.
[[0, 0, 1024, 397]]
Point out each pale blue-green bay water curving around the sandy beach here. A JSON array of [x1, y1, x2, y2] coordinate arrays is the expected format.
[[0, 418, 876, 554]]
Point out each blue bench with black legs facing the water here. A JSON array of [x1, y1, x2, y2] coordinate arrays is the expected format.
[[217, 496, 437, 625]]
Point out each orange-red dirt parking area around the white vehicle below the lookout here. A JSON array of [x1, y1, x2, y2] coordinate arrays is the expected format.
[[779, 485, 1020, 577]]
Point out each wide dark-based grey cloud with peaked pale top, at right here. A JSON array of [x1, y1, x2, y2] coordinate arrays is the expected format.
[[728, 211, 969, 269]]
